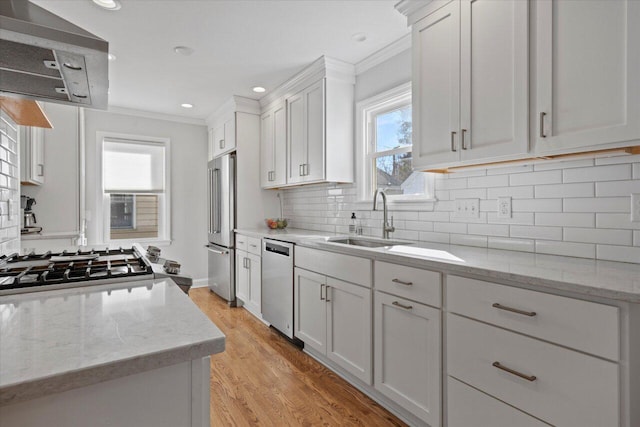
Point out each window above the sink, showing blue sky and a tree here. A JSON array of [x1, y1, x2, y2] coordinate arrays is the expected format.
[[357, 84, 433, 206]]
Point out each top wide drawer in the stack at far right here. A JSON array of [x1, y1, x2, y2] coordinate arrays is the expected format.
[[447, 276, 620, 360]]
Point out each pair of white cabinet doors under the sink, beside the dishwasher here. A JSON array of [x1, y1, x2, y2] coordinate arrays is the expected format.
[[294, 268, 372, 385]]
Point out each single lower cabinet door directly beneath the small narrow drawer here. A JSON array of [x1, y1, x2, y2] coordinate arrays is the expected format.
[[373, 291, 442, 426]]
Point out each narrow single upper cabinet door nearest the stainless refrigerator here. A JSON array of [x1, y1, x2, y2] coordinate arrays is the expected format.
[[260, 102, 287, 188]]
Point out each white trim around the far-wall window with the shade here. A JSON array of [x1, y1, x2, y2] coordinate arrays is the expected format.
[[95, 131, 171, 246]]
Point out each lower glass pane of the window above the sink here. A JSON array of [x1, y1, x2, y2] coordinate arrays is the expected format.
[[373, 152, 425, 195]]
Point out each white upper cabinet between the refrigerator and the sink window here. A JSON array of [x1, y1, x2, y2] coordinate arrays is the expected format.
[[260, 57, 355, 188]]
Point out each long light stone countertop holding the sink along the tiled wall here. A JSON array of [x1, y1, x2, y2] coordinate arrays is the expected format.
[[236, 229, 640, 303]]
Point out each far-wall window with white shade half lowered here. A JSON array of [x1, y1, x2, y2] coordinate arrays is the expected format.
[[99, 135, 170, 243]]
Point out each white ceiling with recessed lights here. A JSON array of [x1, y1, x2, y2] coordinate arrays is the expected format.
[[32, 0, 409, 119]]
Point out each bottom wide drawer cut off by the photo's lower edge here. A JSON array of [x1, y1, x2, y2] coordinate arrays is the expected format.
[[447, 377, 547, 427]]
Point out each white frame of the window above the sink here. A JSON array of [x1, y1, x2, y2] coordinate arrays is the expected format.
[[356, 82, 435, 209]]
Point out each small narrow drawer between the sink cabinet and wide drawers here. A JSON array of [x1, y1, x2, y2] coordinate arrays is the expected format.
[[374, 261, 442, 307]]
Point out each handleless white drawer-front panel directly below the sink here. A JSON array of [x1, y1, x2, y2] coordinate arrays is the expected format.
[[295, 246, 372, 288]]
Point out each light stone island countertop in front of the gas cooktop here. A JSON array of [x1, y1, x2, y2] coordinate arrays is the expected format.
[[0, 279, 225, 405]]
